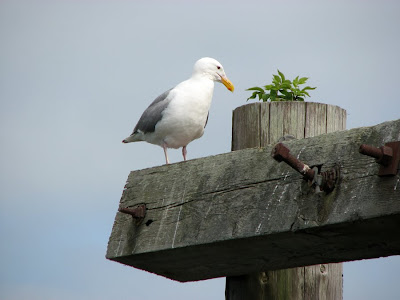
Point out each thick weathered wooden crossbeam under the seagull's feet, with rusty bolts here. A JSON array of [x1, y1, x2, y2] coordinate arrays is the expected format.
[[106, 120, 400, 281]]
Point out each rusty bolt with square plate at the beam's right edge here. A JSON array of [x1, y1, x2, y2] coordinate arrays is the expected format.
[[359, 141, 400, 176]]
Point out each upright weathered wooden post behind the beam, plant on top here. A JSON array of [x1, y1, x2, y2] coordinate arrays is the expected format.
[[225, 102, 346, 300]]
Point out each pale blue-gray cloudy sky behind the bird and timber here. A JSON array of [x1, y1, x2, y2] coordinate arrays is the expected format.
[[0, 0, 400, 300]]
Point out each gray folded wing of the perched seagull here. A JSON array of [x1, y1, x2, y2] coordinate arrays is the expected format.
[[132, 89, 172, 134]]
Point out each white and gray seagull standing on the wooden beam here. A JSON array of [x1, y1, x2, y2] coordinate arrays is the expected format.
[[122, 57, 234, 164]]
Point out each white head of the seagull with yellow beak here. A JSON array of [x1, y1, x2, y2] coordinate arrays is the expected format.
[[193, 57, 235, 92]]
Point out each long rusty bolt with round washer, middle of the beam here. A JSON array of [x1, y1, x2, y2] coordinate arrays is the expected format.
[[272, 143, 339, 193]]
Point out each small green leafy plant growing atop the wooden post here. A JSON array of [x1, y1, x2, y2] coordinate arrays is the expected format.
[[246, 70, 316, 102]]
